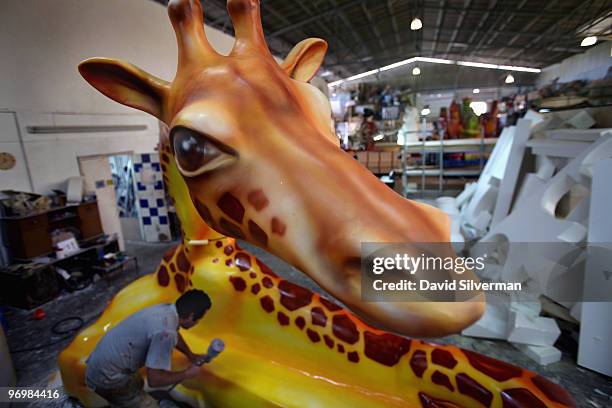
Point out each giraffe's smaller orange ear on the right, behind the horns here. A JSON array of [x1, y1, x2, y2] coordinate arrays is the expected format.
[[281, 38, 327, 82]]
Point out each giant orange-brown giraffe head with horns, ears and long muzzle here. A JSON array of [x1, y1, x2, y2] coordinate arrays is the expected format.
[[79, 0, 482, 335]]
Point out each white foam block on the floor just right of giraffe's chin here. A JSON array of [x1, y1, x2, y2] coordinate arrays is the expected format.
[[507, 310, 561, 346]]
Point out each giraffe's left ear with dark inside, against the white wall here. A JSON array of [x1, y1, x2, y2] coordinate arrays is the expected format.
[[79, 58, 170, 121]]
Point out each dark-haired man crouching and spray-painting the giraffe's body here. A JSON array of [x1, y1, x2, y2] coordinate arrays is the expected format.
[[85, 290, 211, 407]]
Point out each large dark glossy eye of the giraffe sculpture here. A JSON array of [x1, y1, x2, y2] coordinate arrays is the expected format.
[[172, 127, 231, 176]]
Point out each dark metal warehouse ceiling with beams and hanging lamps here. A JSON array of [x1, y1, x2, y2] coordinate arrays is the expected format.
[[156, 0, 612, 80]]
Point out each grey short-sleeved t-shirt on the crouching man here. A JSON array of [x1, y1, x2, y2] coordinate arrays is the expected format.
[[86, 304, 179, 389]]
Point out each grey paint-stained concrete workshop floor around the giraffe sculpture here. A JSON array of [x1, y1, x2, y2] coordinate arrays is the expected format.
[[6, 242, 612, 408]]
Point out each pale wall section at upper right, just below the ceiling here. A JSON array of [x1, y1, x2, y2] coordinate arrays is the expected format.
[[536, 41, 612, 88]]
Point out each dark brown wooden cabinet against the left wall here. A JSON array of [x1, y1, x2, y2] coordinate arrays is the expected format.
[[2, 201, 103, 259]]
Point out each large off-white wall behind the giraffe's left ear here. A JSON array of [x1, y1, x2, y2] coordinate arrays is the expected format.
[[0, 0, 234, 193]]
